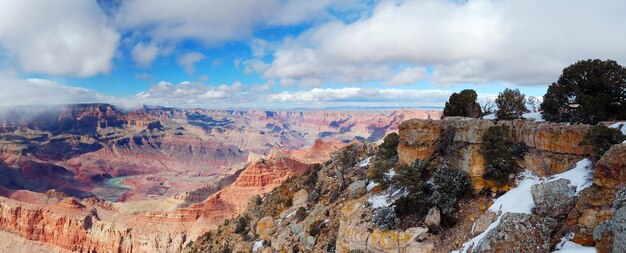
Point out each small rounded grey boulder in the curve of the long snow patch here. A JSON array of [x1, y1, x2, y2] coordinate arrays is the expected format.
[[530, 178, 576, 219]]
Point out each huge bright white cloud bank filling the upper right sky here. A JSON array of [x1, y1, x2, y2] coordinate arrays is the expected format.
[[263, 0, 626, 85]]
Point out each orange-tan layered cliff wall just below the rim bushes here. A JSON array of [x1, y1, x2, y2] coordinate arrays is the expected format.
[[398, 117, 589, 187]]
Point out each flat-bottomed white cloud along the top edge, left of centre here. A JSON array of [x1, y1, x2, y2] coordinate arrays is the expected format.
[[116, 0, 362, 44]]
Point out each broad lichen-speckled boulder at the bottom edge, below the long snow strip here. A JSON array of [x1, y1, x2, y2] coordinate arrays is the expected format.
[[473, 213, 557, 253]]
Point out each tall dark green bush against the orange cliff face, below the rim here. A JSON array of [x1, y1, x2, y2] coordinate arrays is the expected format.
[[480, 126, 515, 185]]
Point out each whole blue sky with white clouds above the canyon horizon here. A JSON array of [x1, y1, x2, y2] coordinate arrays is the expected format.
[[0, 0, 626, 109]]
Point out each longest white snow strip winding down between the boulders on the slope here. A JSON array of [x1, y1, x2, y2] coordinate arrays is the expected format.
[[460, 158, 593, 252]]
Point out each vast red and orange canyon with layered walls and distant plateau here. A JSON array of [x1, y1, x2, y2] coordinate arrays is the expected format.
[[0, 104, 441, 252]]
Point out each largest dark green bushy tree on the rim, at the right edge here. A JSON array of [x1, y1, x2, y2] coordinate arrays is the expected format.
[[540, 60, 626, 124]]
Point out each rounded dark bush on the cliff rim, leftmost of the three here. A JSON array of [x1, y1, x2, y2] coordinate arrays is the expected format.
[[443, 90, 482, 118]]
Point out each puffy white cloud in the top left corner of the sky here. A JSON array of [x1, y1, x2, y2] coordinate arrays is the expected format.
[[0, 0, 119, 76]]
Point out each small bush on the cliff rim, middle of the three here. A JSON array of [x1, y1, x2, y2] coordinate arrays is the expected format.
[[496, 88, 529, 120]]
